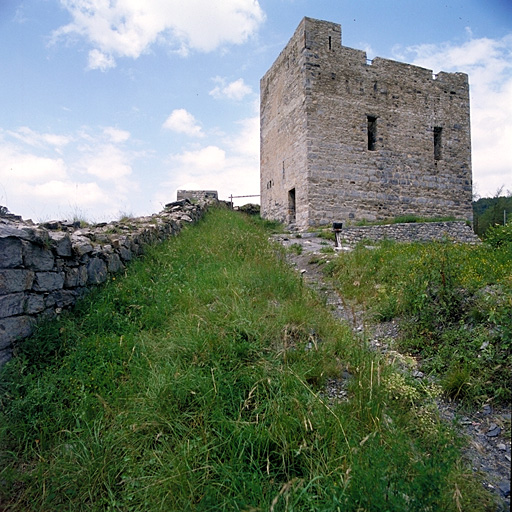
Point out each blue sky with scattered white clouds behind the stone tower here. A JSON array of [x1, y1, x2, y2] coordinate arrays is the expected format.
[[0, 0, 512, 221]]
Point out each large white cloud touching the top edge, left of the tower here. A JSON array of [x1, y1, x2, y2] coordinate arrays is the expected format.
[[52, 0, 265, 71]]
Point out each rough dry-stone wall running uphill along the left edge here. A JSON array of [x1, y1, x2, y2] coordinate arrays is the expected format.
[[0, 200, 207, 365]]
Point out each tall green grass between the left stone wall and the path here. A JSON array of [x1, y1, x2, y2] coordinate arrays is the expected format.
[[0, 210, 493, 512]]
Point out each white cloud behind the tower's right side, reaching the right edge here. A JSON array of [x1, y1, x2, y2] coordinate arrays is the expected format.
[[395, 31, 512, 197]]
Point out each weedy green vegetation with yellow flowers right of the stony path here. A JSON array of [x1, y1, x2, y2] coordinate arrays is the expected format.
[[330, 238, 512, 406]]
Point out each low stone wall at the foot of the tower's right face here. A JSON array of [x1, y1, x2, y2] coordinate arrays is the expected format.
[[337, 221, 480, 244]]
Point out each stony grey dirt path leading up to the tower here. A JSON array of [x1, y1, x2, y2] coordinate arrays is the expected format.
[[273, 233, 511, 512]]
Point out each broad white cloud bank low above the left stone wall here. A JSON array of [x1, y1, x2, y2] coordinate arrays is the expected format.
[[0, 127, 139, 221]]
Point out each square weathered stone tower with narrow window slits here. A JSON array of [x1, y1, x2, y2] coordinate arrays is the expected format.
[[260, 18, 472, 229]]
